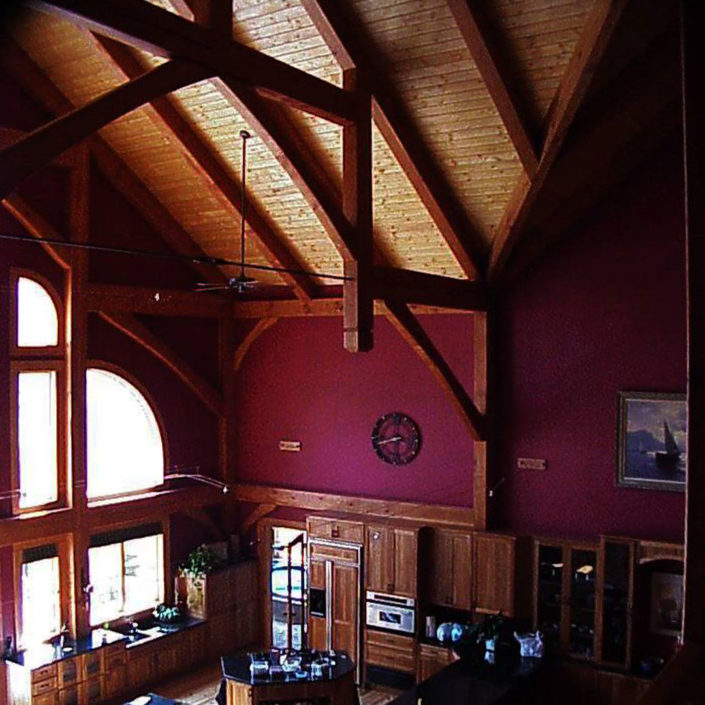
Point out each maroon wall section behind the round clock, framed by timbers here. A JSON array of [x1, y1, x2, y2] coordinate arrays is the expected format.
[[236, 315, 472, 506]]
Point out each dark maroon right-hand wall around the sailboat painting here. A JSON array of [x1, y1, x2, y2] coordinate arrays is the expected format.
[[496, 144, 686, 539]]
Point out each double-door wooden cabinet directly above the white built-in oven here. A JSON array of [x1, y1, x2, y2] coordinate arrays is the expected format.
[[365, 523, 419, 598]]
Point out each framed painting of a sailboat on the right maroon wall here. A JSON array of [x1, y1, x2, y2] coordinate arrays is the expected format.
[[616, 392, 688, 492]]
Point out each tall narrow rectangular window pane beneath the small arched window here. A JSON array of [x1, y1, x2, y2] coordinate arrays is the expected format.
[[17, 371, 58, 507]]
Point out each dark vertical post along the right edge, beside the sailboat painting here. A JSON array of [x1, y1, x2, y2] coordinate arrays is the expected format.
[[681, 0, 705, 644]]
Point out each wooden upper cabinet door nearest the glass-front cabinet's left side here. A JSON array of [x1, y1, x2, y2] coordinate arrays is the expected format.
[[474, 534, 516, 617]]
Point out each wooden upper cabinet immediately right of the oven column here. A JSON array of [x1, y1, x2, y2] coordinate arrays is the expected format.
[[423, 529, 472, 611]]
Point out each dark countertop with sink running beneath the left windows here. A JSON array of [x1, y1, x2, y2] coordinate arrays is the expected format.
[[8, 617, 204, 669]]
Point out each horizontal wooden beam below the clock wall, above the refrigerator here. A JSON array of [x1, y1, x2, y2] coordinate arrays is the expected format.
[[230, 483, 475, 527]]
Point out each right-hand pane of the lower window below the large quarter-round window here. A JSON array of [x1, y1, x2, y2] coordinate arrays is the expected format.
[[123, 534, 164, 614]]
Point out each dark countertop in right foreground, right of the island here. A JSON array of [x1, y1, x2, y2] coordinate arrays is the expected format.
[[390, 657, 543, 705]]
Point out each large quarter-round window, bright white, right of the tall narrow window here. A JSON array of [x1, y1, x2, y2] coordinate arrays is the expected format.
[[86, 368, 164, 499]]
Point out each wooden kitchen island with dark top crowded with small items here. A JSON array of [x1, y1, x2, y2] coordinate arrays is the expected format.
[[221, 651, 358, 705]]
